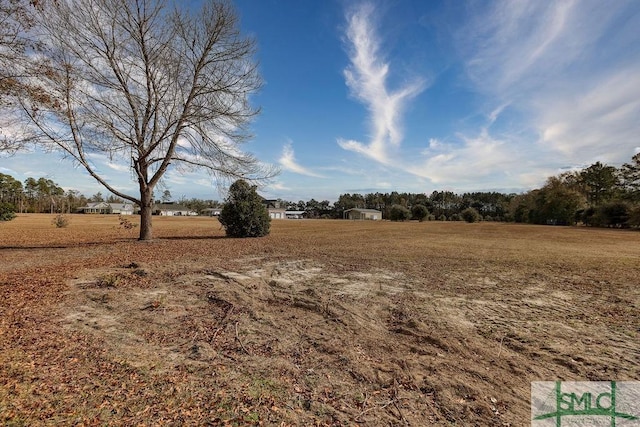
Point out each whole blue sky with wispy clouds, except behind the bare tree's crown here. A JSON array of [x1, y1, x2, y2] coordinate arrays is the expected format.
[[0, 0, 640, 201]]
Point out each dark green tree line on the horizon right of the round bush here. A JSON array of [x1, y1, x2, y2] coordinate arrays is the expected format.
[[280, 153, 640, 227]]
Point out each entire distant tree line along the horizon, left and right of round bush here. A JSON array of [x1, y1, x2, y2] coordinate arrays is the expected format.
[[0, 153, 640, 228]]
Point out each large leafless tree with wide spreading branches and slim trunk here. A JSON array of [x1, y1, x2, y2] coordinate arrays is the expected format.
[[10, 0, 275, 240]]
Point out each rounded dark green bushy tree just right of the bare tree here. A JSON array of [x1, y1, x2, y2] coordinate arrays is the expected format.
[[218, 179, 271, 237]]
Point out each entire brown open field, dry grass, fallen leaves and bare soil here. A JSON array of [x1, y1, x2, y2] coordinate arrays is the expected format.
[[0, 215, 640, 426]]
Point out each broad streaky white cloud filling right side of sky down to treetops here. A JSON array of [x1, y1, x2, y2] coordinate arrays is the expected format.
[[408, 0, 640, 188]]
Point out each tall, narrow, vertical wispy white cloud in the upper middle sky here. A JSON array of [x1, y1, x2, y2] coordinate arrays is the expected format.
[[338, 3, 426, 164]]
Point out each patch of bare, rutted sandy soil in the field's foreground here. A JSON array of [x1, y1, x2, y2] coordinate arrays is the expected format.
[[56, 258, 638, 425]]
